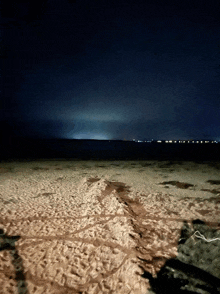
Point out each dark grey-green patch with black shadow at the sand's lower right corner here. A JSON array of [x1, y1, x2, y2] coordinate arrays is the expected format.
[[142, 220, 220, 294]]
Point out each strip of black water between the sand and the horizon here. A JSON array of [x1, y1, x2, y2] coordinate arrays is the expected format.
[[0, 138, 220, 161]]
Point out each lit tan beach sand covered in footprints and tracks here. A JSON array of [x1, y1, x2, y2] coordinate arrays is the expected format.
[[0, 160, 220, 294]]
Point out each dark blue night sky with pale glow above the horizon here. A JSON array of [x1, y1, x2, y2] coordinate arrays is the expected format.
[[0, 0, 220, 140]]
